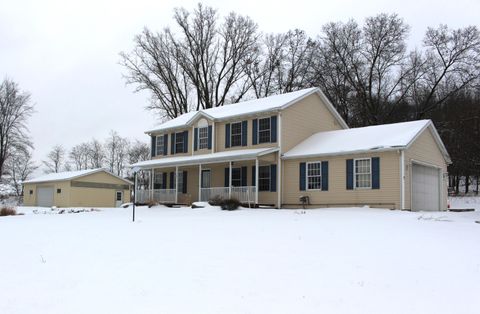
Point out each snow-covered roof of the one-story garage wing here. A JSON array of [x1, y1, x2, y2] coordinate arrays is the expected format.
[[283, 120, 442, 159]]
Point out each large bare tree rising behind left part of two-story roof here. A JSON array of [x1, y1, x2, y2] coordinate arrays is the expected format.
[[120, 4, 258, 118]]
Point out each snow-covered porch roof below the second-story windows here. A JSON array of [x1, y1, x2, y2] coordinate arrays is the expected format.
[[130, 148, 278, 169]]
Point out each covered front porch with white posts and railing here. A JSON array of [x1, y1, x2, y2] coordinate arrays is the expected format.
[[134, 148, 278, 207]]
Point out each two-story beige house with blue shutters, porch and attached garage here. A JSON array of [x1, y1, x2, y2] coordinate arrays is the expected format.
[[132, 88, 450, 210]]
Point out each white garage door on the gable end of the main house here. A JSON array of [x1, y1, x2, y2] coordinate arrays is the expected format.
[[412, 164, 440, 210]]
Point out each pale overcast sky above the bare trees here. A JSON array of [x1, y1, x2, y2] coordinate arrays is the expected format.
[[0, 0, 480, 170]]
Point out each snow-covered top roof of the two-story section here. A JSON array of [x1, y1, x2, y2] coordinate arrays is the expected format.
[[146, 87, 347, 133]]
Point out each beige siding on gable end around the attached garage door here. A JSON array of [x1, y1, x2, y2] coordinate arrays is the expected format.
[[405, 128, 448, 209]]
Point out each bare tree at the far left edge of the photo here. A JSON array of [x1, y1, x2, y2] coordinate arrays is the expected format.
[[0, 79, 33, 181]]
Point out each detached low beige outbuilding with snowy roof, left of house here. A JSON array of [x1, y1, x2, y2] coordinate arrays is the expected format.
[[23, 169, 132, 207]]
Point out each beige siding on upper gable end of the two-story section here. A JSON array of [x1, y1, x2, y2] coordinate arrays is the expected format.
[[281, 93, 342, 153]]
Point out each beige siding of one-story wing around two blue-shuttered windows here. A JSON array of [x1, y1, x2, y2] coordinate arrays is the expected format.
[[283, 151, 400, 209]]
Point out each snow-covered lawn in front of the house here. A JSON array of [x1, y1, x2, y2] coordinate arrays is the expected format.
[[0, 202, 480, 314]]
